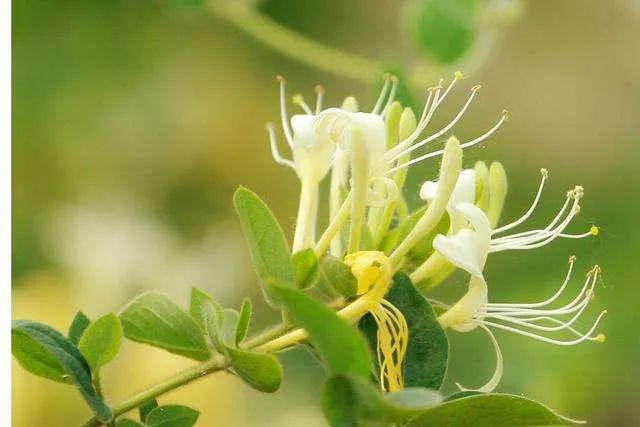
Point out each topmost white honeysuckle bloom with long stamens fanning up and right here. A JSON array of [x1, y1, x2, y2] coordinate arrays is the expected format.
[[268, 72, 507, 255]]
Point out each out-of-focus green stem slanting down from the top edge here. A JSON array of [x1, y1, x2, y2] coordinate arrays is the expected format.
[[209, 0, 382, 83]]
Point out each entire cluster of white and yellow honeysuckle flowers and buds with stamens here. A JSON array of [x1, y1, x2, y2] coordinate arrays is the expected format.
[[267, 72, 605, 392]]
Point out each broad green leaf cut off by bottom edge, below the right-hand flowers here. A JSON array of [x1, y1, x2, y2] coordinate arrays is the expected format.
[[409, 394, 576, 427]]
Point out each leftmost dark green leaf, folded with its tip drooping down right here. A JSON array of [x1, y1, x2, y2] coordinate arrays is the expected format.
[[11, 320, 112, 422]]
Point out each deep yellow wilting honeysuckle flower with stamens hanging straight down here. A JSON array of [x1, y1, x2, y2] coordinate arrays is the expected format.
[[342, 251, 409, 392]]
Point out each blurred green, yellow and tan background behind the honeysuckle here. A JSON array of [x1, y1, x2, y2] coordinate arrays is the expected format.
[[12, 0, 640, 427]]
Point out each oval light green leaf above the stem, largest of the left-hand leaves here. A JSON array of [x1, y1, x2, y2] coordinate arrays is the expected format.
[[120, 292, 211, 360]]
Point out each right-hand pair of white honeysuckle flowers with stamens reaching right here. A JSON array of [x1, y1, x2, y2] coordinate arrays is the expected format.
[[433, 169, 606, 392]]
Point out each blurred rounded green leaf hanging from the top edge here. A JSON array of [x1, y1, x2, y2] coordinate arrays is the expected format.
[[406, 0, 477, 64]]
